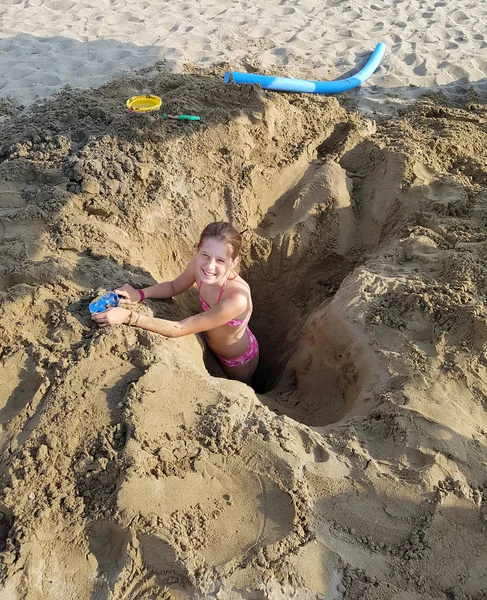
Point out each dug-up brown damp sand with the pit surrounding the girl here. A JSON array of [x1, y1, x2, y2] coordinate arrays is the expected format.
[[0, 74, 487, 600]]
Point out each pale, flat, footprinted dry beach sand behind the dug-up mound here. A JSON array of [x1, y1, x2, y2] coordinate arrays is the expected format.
[[0, 0, 487, 114]]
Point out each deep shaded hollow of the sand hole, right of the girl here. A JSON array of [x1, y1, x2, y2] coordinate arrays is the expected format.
[[244, 155, 386, 426]]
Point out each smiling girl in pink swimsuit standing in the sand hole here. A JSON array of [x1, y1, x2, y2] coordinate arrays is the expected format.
[[92, 222, 259, 383]]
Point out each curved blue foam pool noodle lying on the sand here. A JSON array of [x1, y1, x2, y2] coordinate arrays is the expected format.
[[223, 42, 386, 94]]
